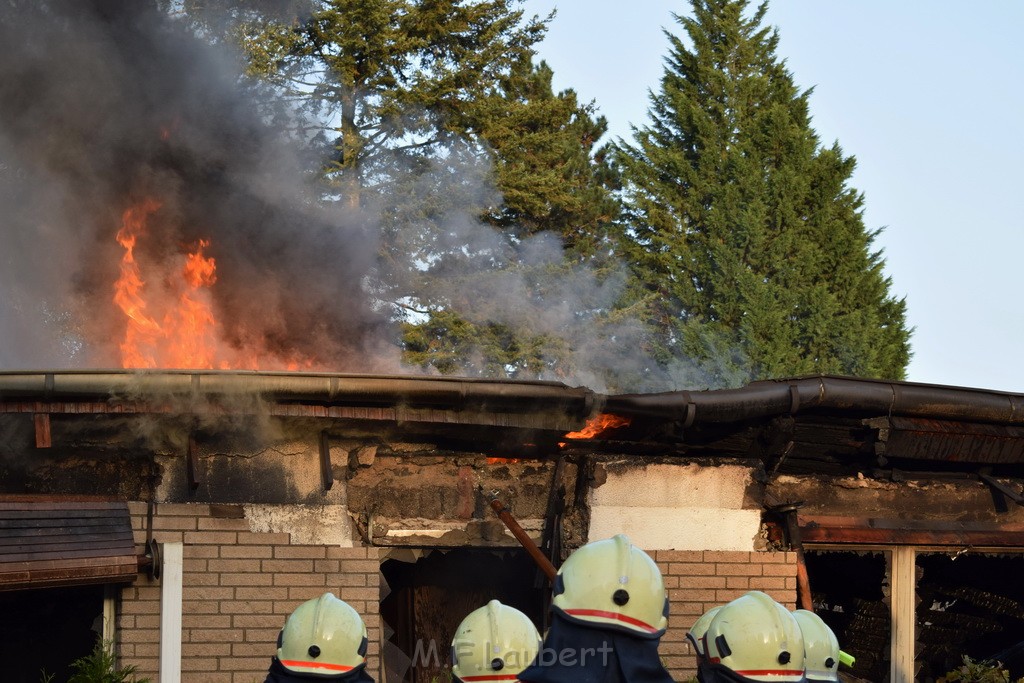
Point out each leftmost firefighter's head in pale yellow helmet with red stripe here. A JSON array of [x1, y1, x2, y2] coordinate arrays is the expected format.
[[264, 593, 374, 683]]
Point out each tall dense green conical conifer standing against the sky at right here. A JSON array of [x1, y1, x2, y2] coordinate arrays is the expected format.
[[617, 0, 910, 386]]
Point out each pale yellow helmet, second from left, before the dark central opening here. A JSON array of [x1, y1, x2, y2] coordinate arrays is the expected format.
[[452, 600, 541, 683]]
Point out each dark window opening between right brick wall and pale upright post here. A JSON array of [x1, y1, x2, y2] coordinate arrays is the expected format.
[[805, 550, 891, 681]]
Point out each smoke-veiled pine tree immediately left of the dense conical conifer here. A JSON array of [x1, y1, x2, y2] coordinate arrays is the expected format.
[[388, 57, 620, 379]]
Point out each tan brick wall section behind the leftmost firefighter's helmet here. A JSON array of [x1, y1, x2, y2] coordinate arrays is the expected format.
[[118, 503, 380, 683]]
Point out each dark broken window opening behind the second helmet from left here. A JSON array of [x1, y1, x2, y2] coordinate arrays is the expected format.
[[381, 549, 549, 683]]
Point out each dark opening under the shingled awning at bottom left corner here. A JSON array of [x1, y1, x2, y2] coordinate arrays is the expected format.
[[0, 586, 103, 683]]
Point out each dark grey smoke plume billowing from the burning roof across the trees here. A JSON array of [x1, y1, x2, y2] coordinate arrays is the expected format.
[[0, 0, 724, 390]]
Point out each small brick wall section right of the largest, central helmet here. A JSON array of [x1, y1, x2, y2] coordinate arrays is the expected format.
[[650, 550, 797, 681]]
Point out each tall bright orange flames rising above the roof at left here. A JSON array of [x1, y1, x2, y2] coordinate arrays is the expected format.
[[114, 198, 217, 369]]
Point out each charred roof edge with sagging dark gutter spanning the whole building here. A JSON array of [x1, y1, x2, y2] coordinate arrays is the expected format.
[[0, 371, 1024, 478]]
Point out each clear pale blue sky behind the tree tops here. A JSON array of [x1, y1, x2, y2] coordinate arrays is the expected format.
[[523, 0, 1024, 393]]
